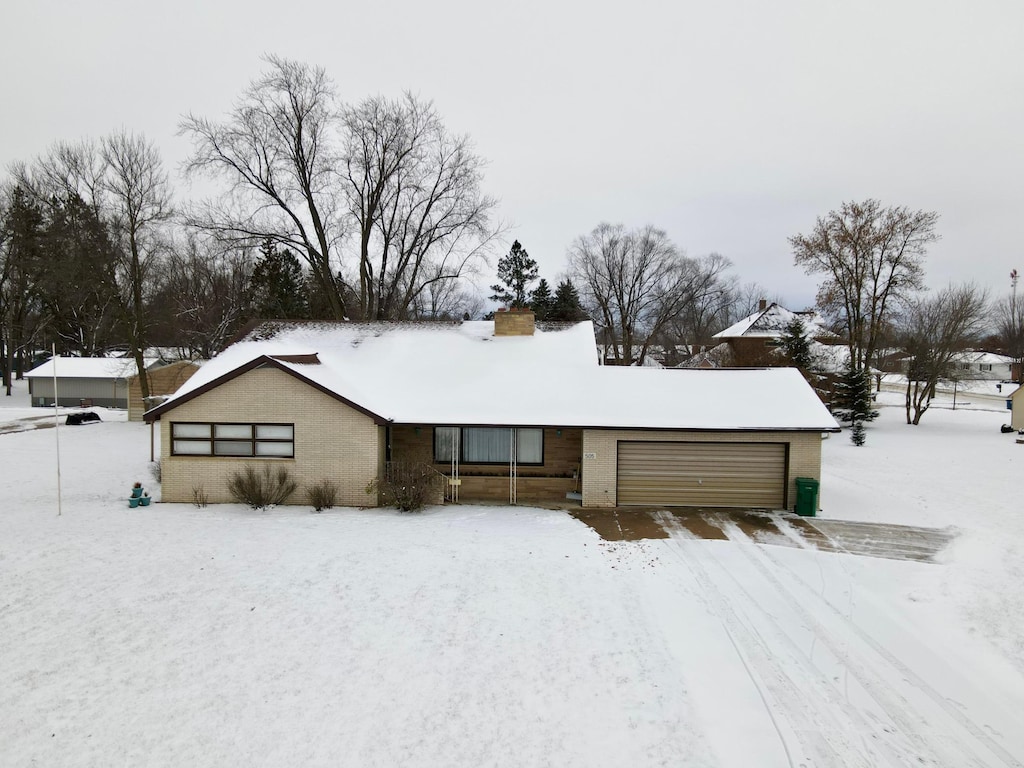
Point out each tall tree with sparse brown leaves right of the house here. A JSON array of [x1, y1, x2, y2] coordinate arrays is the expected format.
[[790, 200, 938, 370]]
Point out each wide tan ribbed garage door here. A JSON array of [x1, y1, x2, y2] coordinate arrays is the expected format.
[[616, 440, 788, 509]]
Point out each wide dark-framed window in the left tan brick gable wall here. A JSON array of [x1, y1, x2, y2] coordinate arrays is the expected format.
[[171, 422, 295, 459]]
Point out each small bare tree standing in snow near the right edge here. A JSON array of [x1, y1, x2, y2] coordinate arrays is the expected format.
[[900, 284, 988, 425]]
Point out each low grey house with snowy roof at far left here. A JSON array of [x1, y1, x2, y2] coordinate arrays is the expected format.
[[25, 356, 161, 409]]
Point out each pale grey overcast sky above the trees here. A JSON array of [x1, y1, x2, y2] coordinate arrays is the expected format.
[[0, 0, 1024, 309]]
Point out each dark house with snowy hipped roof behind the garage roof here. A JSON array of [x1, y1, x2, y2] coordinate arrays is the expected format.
[[712, 300, 839, 367]]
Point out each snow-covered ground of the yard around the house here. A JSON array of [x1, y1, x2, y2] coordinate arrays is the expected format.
[[0, 382, 1024, 767]]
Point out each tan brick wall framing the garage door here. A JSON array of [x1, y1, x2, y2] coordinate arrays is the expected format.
[[583, 429, 821, 508]]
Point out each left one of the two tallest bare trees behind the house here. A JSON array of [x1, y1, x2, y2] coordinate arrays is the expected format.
[[179, 56, 347, 319]]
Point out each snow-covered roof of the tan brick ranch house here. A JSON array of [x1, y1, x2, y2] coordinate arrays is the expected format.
[[151, 322, 836, 430]]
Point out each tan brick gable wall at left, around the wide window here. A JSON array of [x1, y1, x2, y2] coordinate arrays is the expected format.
[[160, 369, 383, 507]]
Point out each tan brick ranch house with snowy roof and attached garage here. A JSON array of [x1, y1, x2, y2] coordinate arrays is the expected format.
[[145, 312, 839, 509]]
